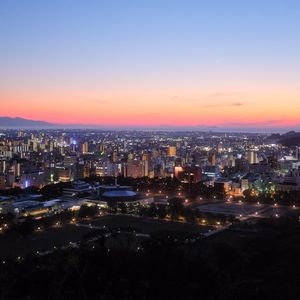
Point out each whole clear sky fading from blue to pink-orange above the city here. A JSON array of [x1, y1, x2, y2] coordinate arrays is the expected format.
[[0, 0, 300, 128]]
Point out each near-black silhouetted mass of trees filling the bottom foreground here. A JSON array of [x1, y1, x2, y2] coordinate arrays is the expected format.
[[0, 220, 300, 300]]
